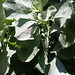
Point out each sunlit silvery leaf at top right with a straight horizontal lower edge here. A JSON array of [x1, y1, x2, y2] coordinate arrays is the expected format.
[[55, 0, 73, 18]]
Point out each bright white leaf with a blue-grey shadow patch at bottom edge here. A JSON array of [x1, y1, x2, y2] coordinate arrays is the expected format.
[[48, 57, 70, 75]]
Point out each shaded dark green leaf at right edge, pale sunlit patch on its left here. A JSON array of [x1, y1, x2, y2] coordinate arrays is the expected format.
[[59, 19, 75, 47]]
